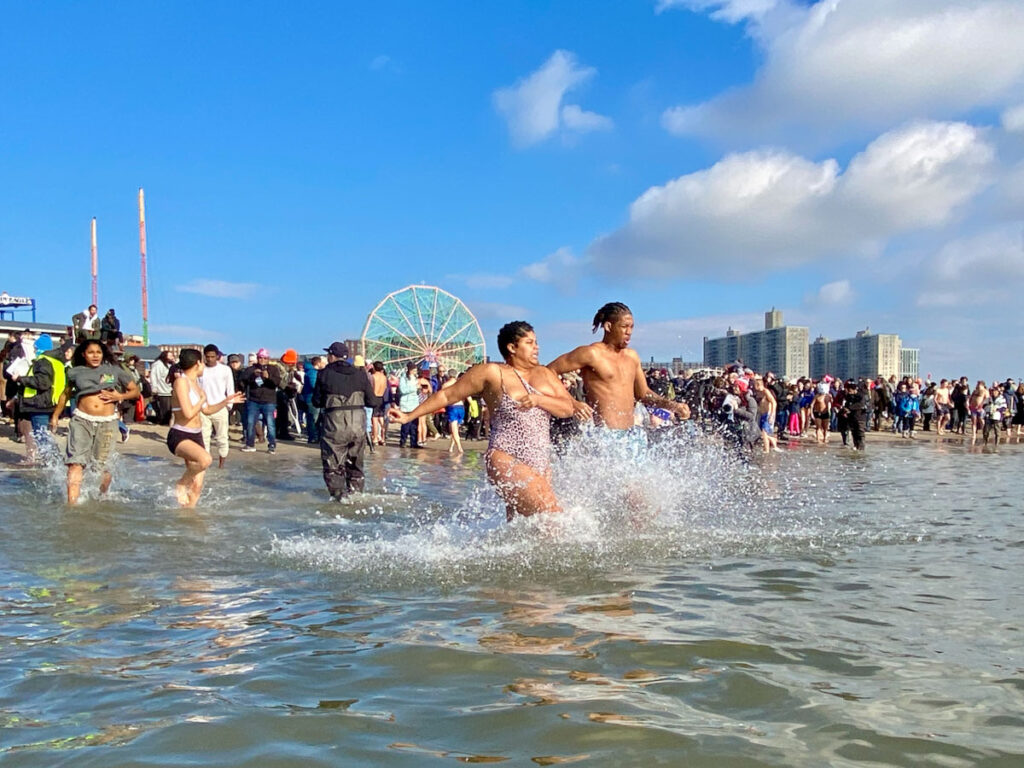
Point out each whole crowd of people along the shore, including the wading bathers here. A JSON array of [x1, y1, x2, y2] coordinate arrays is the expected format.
[[0, 302, 1024, 517]]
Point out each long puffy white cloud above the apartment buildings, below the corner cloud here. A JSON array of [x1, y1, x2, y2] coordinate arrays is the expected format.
[[589, 123, 993, 279]]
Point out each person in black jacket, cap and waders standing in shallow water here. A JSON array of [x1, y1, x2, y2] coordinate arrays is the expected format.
[[312, 341, 381, 501]]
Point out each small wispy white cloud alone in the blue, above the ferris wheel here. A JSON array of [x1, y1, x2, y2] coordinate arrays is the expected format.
[[494, 50, 611, 146]]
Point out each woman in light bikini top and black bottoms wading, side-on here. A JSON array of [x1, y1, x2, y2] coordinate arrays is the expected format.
[[167, 349, 246, 507]]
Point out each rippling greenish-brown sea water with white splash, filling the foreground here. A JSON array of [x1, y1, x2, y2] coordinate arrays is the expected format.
[[0, 438, 1024, 768]]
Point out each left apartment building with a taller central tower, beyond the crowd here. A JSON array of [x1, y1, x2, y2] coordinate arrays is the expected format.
[[703, 307, 809, 379]]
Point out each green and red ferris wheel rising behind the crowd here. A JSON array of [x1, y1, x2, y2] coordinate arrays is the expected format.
[[360, 286, 486, 371]]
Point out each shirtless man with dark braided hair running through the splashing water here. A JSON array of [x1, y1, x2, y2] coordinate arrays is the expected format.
[[548, 301, 690, 430]]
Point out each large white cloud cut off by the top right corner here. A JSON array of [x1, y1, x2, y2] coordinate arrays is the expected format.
[[662, 0, 1024, 140]]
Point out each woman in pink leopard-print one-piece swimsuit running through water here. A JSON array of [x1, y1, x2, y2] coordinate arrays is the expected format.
[[390, 321, 572, 519]]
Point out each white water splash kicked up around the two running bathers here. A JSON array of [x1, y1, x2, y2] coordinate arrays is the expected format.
[[269, 429, 917, 587]]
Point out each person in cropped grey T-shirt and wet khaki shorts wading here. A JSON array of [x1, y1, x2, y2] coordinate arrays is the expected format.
[[50, 339, 139, 504]]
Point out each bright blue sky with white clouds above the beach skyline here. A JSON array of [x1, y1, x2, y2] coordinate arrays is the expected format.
[[0, 0, 1024, 377]]
